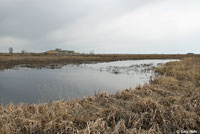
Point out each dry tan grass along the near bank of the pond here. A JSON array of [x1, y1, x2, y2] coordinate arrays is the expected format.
[[0, 57, 200, 134]]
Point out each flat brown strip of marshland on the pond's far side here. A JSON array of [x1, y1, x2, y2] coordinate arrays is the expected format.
[[0, 53, 199, 70]]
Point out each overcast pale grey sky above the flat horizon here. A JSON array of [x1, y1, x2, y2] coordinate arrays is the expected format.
[[0, 0, 200, 54]]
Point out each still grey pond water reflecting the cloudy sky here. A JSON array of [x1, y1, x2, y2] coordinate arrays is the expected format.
[[0, 60, 177, 104]]
